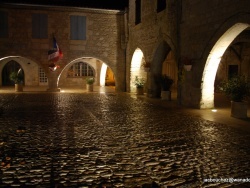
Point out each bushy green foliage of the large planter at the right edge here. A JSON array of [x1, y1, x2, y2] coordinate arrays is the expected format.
[[219, 75, 250, 102]]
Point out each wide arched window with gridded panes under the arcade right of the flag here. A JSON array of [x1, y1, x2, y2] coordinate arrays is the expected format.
[[68, 62, 94, 77]]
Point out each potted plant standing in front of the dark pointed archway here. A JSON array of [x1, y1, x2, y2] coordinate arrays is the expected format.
[[160, 74, 174, 101]]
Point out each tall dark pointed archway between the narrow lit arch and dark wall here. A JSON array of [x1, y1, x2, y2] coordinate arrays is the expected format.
[[148, 41, 171, 98]]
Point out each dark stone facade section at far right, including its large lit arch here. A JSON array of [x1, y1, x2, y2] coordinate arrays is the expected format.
[[180, 0, 250, 108]]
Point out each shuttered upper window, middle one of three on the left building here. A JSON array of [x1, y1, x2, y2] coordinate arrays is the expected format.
[[32, 14, 48, 39]]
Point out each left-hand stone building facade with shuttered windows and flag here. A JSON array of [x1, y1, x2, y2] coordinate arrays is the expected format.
[[0, 4, 125, 91]]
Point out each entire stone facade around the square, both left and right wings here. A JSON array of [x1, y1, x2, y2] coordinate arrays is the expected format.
[[0, 0, 250, 108]]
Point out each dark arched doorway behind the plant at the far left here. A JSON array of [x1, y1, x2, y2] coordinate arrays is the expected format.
[[2, 60, 25, 86]]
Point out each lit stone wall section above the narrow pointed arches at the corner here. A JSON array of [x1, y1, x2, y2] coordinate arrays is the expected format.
[[126, 0, 178, 97]]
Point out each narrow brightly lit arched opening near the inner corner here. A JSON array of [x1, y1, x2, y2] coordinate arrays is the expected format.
[[130, 48, 147, 92]]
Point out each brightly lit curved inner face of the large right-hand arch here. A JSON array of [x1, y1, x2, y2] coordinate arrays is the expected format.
[[200, 23, 249, 109]]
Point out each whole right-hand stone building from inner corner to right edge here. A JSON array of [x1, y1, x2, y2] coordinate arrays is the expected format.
[[127, 0, 250, 108]]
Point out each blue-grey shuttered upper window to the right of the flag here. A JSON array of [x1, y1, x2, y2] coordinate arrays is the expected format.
[[70, 16, 86, 40]]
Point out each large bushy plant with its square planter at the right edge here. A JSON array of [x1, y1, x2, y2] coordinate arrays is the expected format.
[[219, 75, 250, 118]]
